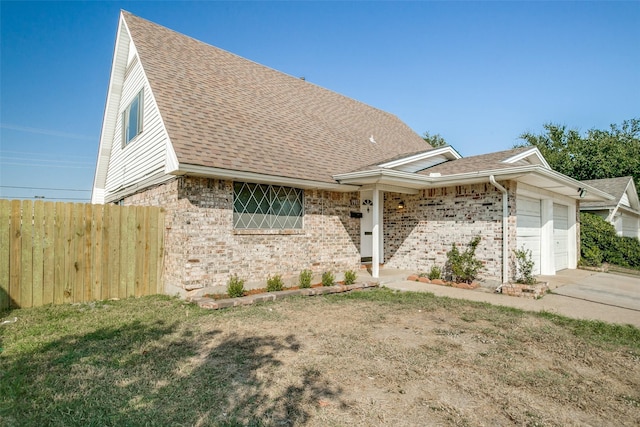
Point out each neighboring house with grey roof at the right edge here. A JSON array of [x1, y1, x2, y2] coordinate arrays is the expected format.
[[580, 176, 640, 239]]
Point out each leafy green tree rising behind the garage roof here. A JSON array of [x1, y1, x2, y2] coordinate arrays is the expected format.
[[516, 118, 640, 196]]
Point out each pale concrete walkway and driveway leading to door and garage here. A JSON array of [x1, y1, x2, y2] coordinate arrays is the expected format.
[[364, 269, 640, 328]]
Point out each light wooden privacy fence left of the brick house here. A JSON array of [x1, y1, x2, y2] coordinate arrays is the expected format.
[[0, 200, 164, 310]]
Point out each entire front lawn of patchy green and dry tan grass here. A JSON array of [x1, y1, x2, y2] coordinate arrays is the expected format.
[[0, 289, 640, 426]]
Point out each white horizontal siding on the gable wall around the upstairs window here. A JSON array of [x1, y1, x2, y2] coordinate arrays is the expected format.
[[105, 55, 171, 202]]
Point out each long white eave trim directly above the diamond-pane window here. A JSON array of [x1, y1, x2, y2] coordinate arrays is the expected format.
[[178, 163, 360, 192]]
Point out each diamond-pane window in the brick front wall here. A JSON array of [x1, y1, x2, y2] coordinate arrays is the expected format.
[[233, 182, 304, 230]]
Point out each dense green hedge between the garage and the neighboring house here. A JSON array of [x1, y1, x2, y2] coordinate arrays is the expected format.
[[580, 212, 640, 269]]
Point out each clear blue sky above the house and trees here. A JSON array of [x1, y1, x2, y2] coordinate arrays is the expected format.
[[0, 1, 640, 201]]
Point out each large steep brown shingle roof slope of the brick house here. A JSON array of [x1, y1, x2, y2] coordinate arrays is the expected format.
[[122, 12, 430, 183]]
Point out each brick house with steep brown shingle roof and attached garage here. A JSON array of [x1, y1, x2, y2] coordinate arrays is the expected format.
[[92, 11, 611, 293]]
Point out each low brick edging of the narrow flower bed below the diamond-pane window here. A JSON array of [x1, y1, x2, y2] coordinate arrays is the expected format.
[[191, 282, 378, 310]]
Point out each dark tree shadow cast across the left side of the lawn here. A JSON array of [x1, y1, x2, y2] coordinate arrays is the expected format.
[[0, 321, 341, 426]]
